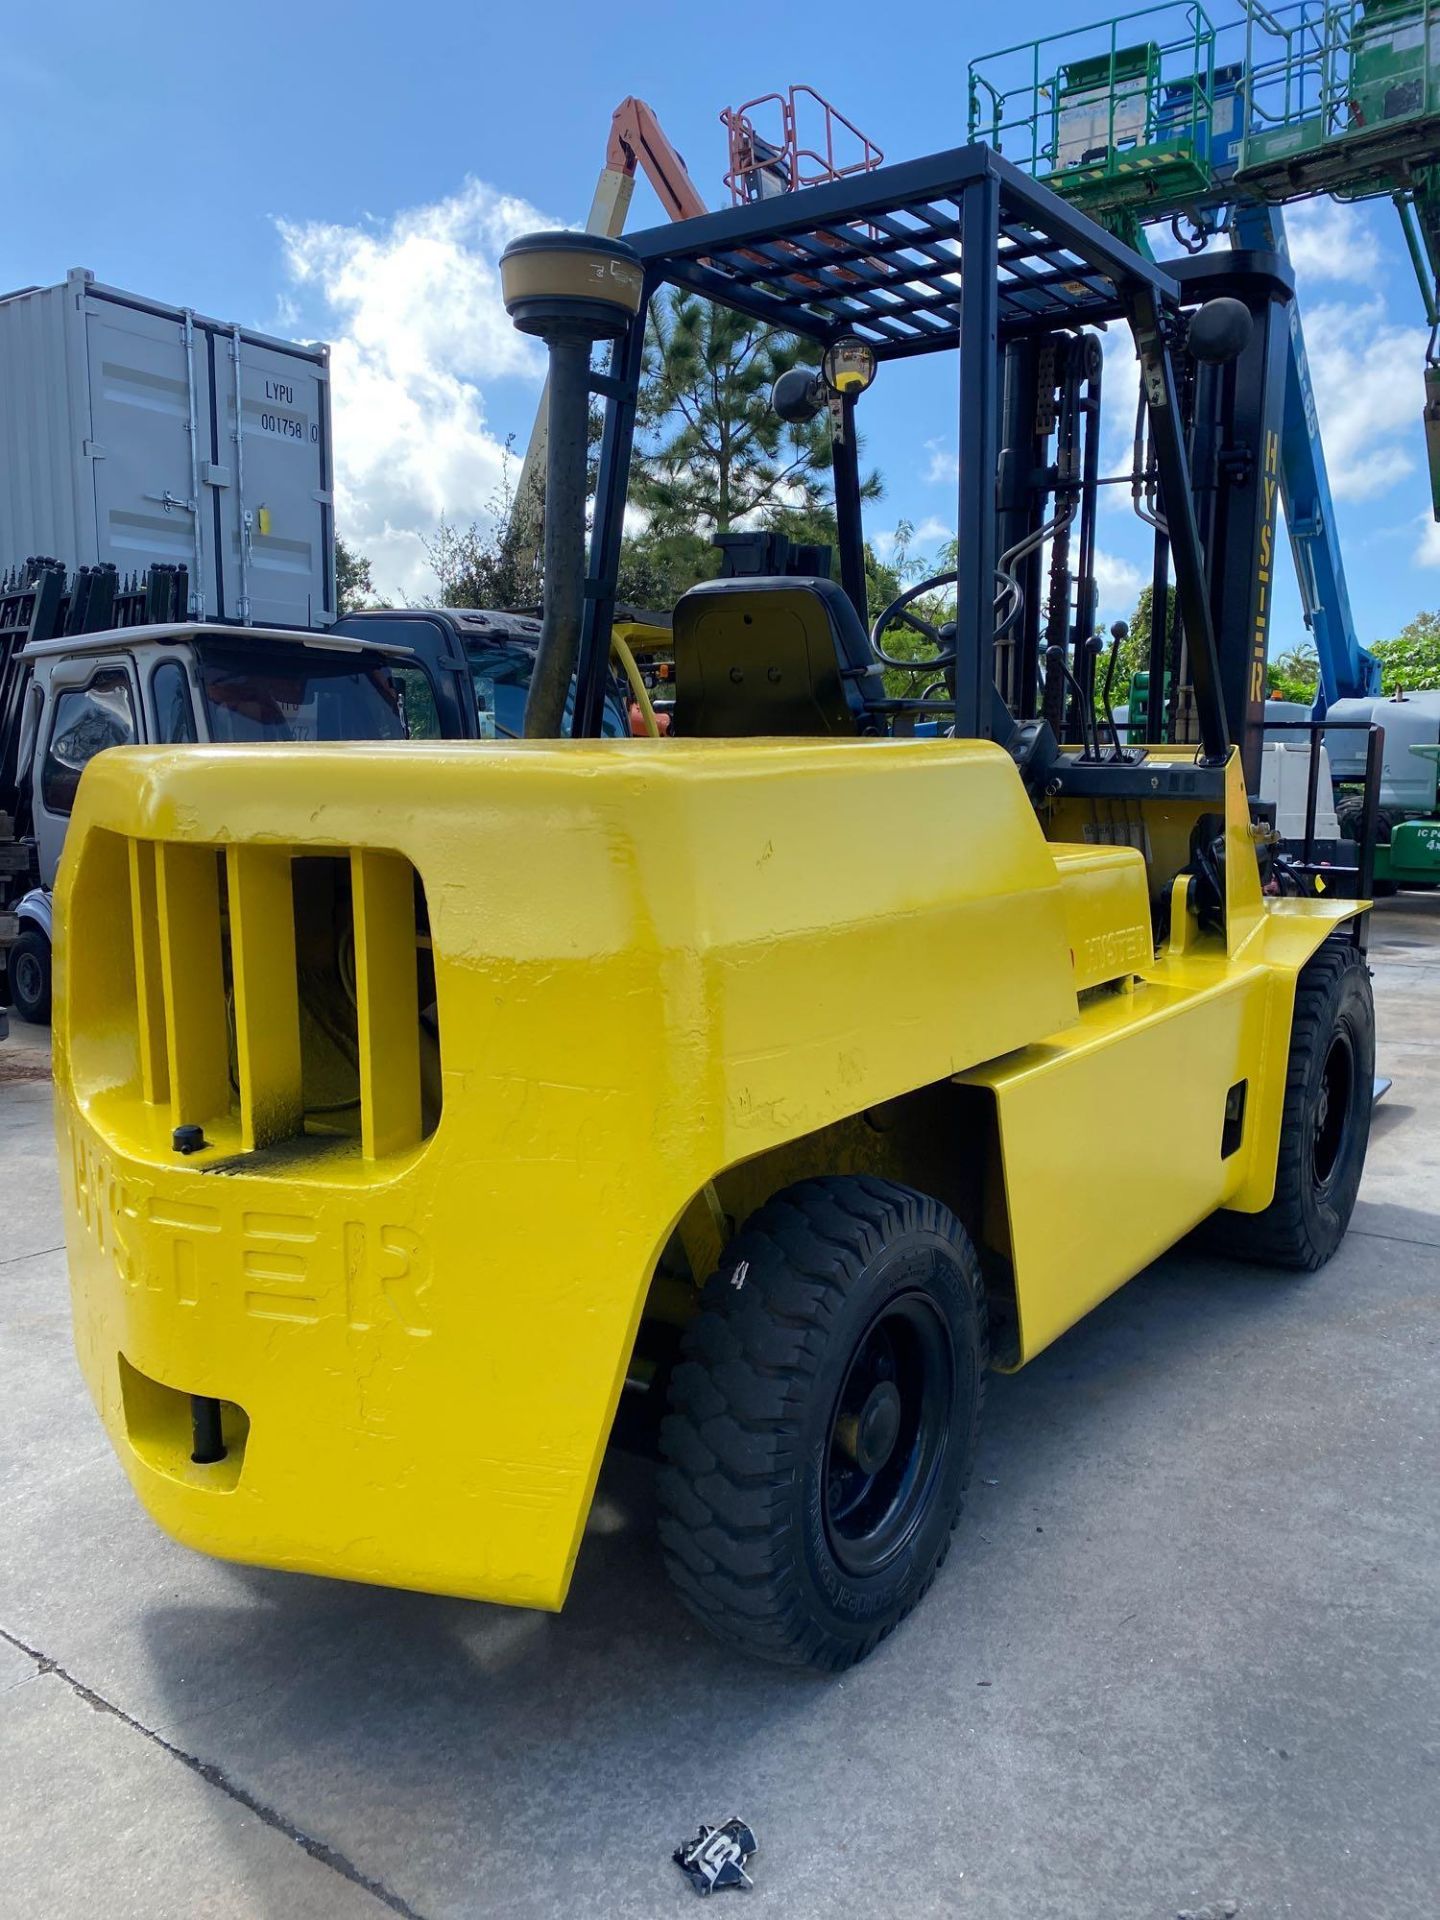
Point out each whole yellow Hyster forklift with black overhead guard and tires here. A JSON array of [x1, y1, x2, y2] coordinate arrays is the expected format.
[[56, 146, 1375, 1668]]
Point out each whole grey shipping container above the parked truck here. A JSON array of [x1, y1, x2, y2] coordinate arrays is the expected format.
[[0, 267, 336, 626]]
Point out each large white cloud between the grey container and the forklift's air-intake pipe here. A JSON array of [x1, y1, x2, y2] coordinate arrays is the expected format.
[[278, 179, 557, 599]]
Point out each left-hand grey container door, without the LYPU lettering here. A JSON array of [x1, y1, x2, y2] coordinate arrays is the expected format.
[[84, 298, 208, 614]]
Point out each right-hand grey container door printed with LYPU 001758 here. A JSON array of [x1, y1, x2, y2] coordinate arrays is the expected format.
[[215, 332, 334, 626]]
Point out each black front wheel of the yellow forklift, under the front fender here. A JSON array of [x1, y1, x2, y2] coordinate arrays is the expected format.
[[1217, 935, 1375, 1273]]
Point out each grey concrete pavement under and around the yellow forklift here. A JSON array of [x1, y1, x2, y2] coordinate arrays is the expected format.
[[0, 899, 1440, 1920]]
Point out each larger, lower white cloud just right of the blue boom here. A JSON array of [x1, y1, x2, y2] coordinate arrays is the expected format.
[[1306, 298, 1427, 499]]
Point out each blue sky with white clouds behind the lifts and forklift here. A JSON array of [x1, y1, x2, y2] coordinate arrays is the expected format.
[[0, 0, 1440, 651]]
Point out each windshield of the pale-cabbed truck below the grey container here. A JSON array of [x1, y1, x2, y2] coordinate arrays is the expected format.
[[200, 645, 407, 743]]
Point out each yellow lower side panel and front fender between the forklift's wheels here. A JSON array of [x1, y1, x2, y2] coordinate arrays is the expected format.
[[962, 749, 1359, 1363]]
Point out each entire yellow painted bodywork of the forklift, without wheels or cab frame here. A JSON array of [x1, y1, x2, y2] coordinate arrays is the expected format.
[[56, 739, 1367, 1607]]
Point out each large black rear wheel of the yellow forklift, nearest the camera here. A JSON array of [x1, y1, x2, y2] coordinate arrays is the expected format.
[[659, 1177, 989, 1672]]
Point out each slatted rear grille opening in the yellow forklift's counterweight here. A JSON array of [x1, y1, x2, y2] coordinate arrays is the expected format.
[[67, 833, 440, 1169]]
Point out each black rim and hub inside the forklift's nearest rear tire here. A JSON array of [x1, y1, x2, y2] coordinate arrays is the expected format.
[[824, 1292, 954, 1574]]
